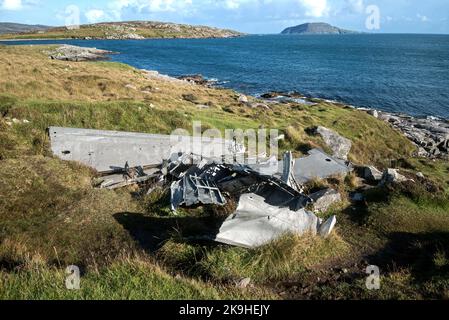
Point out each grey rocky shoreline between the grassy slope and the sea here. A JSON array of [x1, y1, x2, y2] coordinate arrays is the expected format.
[[4, 44, 449, 160]]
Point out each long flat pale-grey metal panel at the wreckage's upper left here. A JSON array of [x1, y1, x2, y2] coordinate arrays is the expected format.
[[49, 127, 244, 173]]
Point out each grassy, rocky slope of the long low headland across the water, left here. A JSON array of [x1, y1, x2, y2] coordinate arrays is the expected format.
[[0, 22, 241, 40]]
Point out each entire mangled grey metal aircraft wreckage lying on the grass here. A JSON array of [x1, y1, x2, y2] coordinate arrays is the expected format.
[[48, 127, 352, 248]]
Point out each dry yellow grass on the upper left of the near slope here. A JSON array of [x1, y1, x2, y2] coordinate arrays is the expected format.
[[0, 46, 238, 108]]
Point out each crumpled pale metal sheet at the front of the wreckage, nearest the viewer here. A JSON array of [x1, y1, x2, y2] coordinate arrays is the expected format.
[[215, 193, 336, 249]]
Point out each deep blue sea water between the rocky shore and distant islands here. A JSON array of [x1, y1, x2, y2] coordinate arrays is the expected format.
[[5, 34, 449, 118]]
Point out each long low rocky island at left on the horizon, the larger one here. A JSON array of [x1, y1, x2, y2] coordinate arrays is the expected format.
[[0, 21, 244, 40]]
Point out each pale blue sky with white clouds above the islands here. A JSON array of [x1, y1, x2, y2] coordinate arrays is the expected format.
[[0, 0, 449, 34]]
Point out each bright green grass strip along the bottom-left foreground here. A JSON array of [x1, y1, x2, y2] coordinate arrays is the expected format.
[[0, 258, 272, 300]]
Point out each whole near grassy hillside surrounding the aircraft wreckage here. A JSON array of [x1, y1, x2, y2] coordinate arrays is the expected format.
[[0, 46, 449, 298]]
